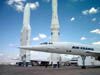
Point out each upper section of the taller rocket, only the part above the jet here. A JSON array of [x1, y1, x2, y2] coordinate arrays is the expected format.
[[51, 0, 60, 42]]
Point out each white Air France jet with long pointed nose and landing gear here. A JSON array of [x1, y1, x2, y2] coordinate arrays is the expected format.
[[19, 42, 100, 69]]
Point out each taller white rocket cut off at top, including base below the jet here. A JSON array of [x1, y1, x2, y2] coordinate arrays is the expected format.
[[50, 0, 60, 64]]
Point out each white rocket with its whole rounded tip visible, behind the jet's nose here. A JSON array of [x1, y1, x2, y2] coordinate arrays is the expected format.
[[20, 3, 31, 62]]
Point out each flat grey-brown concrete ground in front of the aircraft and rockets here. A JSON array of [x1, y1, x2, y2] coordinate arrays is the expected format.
[[0, 65, 100, 75]]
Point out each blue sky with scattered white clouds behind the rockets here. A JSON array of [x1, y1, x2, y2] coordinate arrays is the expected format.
[[0, 0, 100, 62]]
